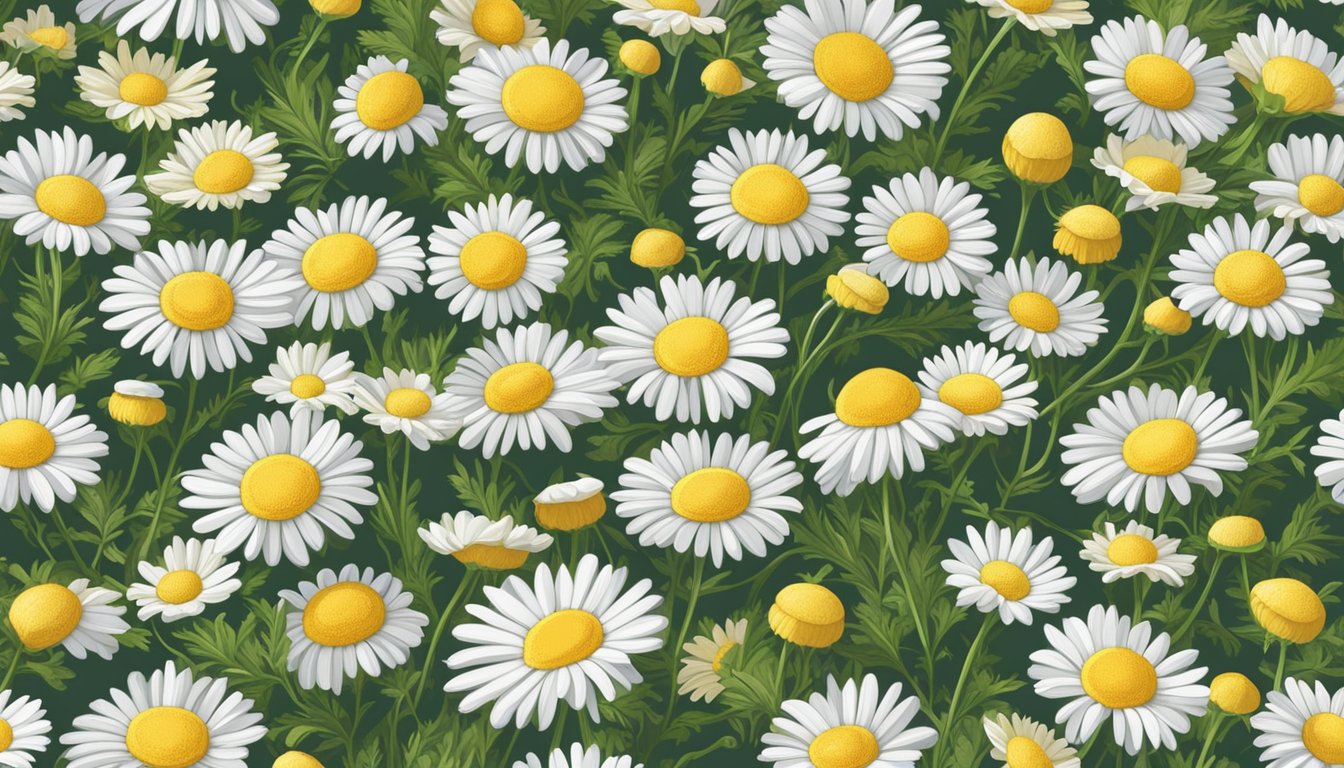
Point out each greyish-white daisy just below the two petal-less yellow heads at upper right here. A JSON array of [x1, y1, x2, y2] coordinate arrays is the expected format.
[[974, 258, 1106, 358]]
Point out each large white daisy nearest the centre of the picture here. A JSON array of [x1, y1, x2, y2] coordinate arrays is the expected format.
[[593, 274, 789, 424]]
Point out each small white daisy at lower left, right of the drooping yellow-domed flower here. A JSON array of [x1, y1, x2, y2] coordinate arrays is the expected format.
[[126, 537, 243, 621]]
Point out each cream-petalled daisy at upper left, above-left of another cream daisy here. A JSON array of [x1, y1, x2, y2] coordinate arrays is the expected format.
[[75, 40, 215, 130]]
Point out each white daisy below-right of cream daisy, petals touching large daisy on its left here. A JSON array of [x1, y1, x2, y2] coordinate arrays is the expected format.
[[261, 196, 425, 330]]
